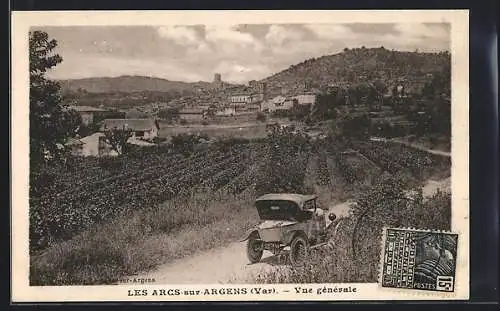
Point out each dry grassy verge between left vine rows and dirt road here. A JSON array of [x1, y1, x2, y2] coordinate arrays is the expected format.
[[30, 192, 257, 286]]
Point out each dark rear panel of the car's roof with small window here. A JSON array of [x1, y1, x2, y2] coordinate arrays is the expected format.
[[255, 200, 300, 221]]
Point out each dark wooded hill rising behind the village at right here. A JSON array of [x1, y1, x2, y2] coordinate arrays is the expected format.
[[261, 47, 451, 95]]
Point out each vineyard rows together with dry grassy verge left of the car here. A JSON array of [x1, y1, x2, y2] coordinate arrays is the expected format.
[[30, 129, 449, 285]]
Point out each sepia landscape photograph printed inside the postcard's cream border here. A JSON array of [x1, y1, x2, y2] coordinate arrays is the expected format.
[[10, 9, 468, 299]]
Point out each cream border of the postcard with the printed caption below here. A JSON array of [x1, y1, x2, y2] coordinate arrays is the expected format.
[[11, 10, 469, 302]]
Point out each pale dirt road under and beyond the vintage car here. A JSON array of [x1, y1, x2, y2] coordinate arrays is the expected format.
[[126, 178, 450, 284]]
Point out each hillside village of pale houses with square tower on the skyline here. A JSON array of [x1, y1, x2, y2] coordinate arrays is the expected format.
[[65, 73, 324, 157]]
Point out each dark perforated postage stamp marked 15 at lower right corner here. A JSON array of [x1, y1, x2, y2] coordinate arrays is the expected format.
[[381, 228, 458, 292]]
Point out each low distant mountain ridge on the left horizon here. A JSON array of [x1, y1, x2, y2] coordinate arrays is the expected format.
[[59, 76, 223, 93]]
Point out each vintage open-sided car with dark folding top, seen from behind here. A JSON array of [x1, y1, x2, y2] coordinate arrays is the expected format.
[[241, 193, 337, 265]]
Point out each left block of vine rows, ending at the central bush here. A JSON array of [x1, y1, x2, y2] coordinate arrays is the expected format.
[[30, 144, 264, 249]]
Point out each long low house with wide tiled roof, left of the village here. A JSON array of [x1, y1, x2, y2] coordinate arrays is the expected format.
[[101, 119, 160, 140]]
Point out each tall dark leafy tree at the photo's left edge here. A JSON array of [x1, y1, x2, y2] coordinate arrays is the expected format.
[[29, 31, 81, 166]]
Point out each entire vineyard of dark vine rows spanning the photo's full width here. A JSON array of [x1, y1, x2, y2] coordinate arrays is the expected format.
[[30, 130, 450, 254]]
